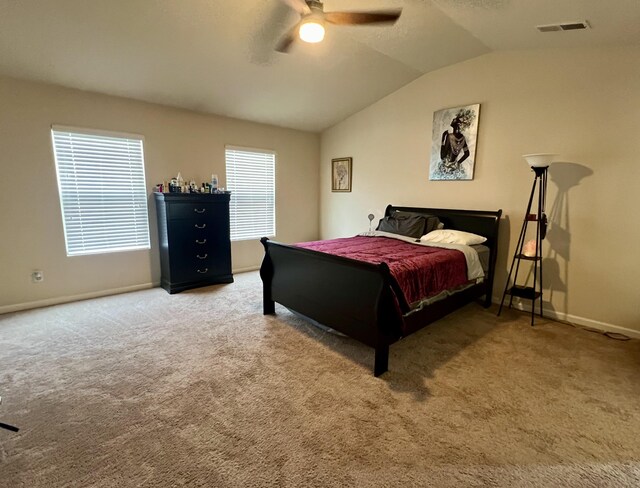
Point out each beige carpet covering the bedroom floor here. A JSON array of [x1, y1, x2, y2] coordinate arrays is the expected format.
[[0, 273, 640, 487]]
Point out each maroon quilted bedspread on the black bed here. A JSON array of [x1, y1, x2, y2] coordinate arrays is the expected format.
[[296, 236, 468, 306]]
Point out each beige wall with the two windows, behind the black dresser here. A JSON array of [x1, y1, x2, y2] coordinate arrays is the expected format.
[[0, 78, 320, 312]]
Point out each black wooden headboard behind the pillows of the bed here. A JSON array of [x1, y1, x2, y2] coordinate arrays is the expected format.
[[384, 205, 502, 291]]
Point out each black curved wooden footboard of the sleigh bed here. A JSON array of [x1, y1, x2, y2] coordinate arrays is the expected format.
[[260, 238, 402, 376]]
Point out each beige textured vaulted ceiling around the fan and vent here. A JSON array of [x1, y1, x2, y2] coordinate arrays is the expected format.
[[0, 0, 640, 131]]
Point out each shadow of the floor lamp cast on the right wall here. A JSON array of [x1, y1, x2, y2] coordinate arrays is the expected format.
[[542, 162, 593, 312]]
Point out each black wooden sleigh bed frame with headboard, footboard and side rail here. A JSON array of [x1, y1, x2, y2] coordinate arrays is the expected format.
[[260, 205, 502, 376]]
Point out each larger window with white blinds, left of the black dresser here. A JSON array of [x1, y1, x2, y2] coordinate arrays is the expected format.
[[51, 126, 150, 256]]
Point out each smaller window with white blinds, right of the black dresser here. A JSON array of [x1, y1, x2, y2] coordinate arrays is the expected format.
[[226, 146, 276, 241]]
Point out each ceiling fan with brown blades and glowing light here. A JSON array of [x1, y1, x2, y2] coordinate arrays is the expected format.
[[276, 0, 402, 53]]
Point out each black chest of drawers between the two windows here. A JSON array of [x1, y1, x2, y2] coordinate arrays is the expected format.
[[154, 193, 233, 293]]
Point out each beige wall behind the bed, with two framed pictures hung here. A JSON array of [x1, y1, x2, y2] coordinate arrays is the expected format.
[[320, 47, 640, 332]]
